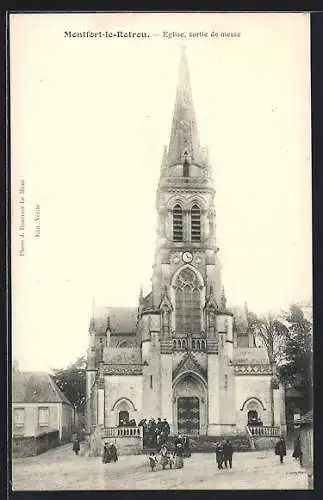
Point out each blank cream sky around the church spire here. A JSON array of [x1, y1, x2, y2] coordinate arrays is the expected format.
[[10, 13, 312, 370]]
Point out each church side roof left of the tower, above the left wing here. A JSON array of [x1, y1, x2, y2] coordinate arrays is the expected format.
[[93, 307, 138, 335]]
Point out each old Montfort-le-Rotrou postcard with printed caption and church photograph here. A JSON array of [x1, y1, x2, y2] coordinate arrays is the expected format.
[[9, 12, 313, 491]]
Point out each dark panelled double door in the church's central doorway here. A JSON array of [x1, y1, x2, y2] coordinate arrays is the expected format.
[[177, 397, 200, 434]]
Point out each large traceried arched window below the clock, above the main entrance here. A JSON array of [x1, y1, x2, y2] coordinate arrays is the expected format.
[[174, 268, 201, 333]]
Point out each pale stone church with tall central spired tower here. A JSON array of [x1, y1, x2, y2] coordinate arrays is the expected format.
[[86, 49, 285, 436]]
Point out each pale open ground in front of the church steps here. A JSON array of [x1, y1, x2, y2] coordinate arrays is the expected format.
[[12, 445, 308, 491]]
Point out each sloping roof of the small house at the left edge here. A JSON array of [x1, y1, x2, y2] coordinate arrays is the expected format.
[[12, 372, 71, 405]]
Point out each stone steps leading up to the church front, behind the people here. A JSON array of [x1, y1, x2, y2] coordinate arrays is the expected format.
[[143, 434, 252, 454]]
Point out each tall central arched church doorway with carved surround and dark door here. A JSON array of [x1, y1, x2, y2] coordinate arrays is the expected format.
[[173, 372, 207, 435]]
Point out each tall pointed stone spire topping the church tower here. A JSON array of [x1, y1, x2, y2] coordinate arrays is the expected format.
[[167, 47, 204, 166]]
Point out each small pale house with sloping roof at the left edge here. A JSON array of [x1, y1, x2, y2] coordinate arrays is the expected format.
[[12, 371, 74, 456]]
